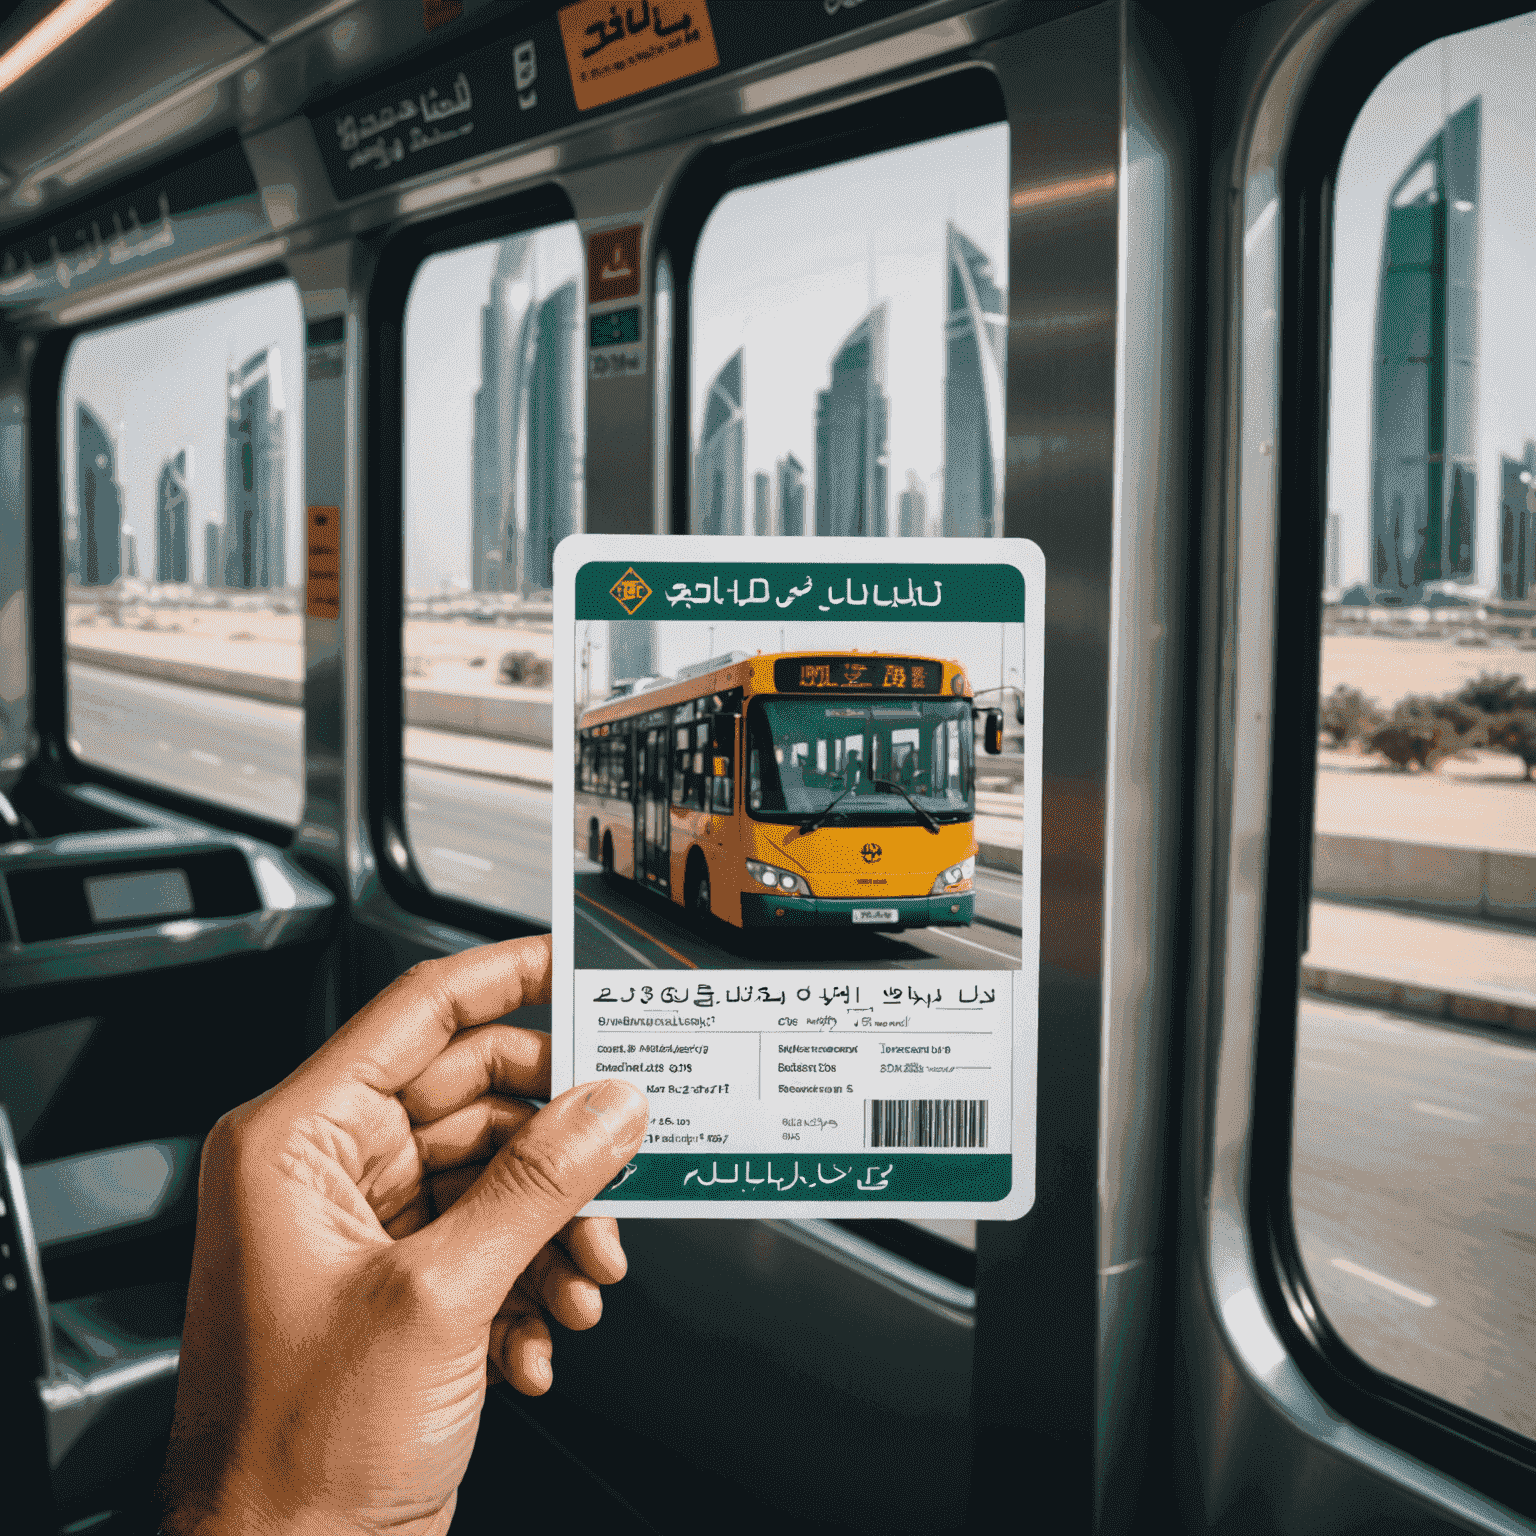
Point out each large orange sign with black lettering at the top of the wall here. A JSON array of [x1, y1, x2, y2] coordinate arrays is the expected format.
[[561, 0, 720, 112]]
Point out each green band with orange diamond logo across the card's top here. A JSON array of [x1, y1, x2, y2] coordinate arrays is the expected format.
[[576, 558, 1025, 624]]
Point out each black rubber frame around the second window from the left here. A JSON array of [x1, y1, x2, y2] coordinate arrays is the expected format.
[[362, 183, 576, 938]]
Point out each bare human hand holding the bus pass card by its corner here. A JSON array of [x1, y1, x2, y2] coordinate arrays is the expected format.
[[164, 938, 647, 1536]]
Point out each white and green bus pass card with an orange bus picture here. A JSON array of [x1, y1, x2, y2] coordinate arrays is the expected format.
[[553, 535, 1044, 1220]]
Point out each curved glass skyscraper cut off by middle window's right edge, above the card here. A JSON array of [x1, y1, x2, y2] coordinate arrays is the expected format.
[[945, 224, 1008, 539]]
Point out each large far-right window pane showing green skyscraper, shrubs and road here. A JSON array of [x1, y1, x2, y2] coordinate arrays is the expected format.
[[1292, 15, 1536, 1435]]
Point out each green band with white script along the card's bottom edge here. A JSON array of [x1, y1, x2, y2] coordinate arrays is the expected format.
[[599, 1152, 1014, 1206]]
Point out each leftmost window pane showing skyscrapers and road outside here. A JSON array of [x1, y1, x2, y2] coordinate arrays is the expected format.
[[60, 283, 304, 823]]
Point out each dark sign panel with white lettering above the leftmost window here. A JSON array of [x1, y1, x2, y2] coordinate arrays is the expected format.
[[0, 144, 269, 306]]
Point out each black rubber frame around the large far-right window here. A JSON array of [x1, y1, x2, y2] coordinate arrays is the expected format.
[[1247, 0, 1536, 1516]]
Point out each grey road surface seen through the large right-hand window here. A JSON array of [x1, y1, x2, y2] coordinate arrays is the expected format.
[[1292, 1000, 1536, 1436]]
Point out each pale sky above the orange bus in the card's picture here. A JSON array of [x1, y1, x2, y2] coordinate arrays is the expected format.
[[576, 619, 1025, 708]]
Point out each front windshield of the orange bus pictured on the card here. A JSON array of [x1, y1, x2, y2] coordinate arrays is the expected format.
[[746, 697, 975, 822]]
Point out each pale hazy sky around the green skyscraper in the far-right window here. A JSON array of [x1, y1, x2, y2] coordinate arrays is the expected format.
[[1329, 15, 1536, 587]]
